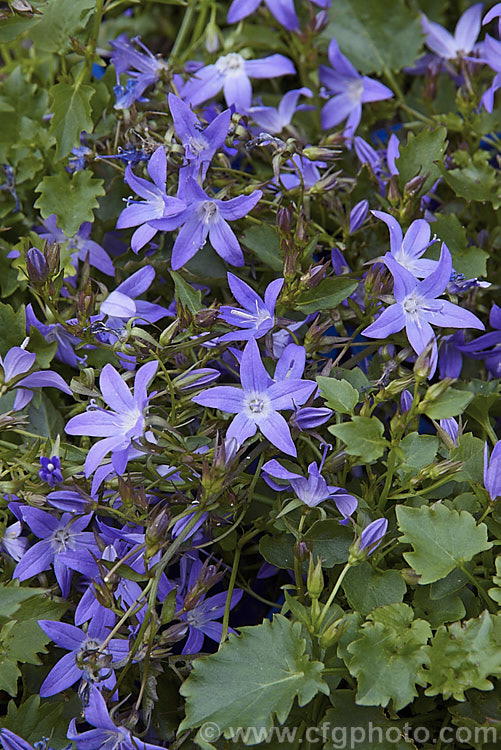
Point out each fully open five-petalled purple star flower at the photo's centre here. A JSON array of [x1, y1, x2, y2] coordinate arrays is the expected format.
[[192, 339, 317, 456]]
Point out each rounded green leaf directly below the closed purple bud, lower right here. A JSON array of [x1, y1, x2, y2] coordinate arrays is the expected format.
[[343, 562, 407, 616]]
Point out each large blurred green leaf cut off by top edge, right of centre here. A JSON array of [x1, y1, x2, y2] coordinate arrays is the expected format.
[[322, 0, 423, 74]]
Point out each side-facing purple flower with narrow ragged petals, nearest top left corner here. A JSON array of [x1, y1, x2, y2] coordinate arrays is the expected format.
[[110, 34, 167, 109]]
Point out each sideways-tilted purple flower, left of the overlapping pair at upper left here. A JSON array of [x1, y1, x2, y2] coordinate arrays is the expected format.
[[117, 146, 186, 253]]
